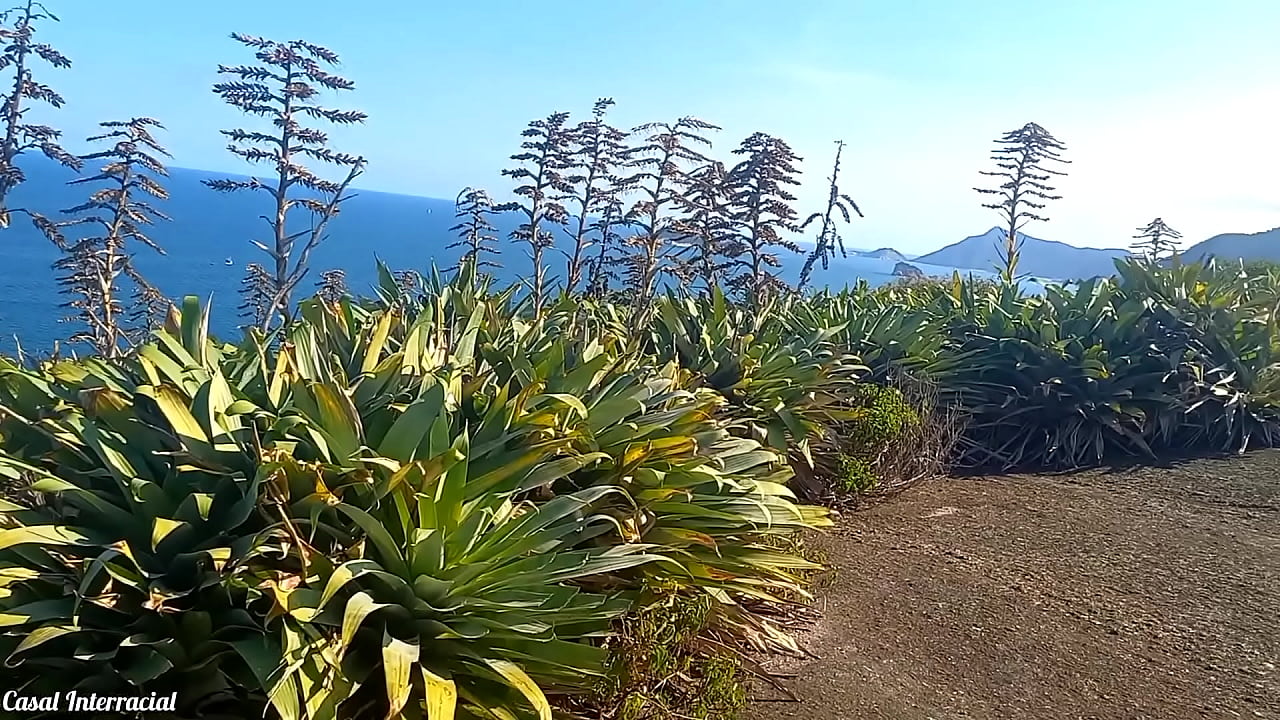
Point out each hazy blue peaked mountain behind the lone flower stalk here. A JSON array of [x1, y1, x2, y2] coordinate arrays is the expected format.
[[916, 228, 1129, 279]]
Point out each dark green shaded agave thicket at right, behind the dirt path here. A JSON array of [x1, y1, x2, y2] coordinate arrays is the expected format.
[[780, 254, 1280, 470]]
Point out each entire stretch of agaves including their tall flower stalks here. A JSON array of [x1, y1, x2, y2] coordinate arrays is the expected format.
[[0, 3, 1280, 720]]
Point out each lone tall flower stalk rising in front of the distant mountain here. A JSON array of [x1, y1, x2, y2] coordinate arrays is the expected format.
[[974, 123, 1069, 283]]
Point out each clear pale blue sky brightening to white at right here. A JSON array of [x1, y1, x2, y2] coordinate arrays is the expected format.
[[33, 0, 1280, 252]]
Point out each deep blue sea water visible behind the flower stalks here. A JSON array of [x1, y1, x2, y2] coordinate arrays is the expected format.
[[0, 161, 987, 354]]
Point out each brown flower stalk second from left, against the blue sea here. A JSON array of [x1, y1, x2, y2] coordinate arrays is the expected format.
[[54, 118, 169, 357]]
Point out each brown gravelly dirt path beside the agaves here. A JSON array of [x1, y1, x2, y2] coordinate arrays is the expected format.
[[746, 451, 1280, 720]]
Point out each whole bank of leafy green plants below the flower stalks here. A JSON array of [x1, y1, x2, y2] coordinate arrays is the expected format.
[[0, 254, 1280, 720]]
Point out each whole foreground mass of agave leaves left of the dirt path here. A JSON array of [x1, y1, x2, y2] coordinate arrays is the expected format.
[[0, 266, 828, 719]]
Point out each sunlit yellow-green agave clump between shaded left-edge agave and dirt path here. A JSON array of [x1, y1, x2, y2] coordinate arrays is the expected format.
[[165, 271, 829, 717]]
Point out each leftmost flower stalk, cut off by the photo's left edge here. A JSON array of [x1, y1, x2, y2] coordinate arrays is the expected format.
[[0, 0, 83, 226]]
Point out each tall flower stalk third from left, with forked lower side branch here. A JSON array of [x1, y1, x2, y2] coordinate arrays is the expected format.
[[205, 33, 367, 331]]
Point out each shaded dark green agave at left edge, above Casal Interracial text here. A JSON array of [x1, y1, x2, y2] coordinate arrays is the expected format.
[[0, 298, 280, 711]]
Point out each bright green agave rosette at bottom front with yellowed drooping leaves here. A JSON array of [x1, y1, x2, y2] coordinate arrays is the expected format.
[[273, 450, 659, 719]]
